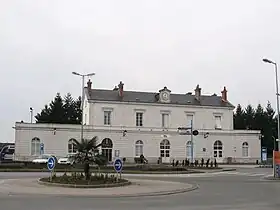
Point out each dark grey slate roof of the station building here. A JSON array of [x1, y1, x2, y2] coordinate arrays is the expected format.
[[85, 88, 234, 109]]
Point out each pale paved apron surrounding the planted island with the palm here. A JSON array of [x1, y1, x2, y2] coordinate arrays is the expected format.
[[0, 179, 197, 198]]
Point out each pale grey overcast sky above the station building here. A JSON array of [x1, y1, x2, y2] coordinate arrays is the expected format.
[[0, 0, 280, 142]]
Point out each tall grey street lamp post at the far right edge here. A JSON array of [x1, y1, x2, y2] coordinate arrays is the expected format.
[[263, 58, 280, 177]]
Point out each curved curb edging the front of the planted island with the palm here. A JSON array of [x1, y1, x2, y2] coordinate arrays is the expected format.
[[38, 179, 131, 189]]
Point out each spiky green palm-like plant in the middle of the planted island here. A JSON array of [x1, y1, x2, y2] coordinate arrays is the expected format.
[[70, 136, 108, 180]]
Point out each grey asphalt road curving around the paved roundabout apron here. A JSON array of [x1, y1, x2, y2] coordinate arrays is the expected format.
[[0, 168, 280, 210]]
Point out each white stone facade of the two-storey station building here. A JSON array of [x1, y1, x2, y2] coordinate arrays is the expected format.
[[15, 83, 261, 163]]
